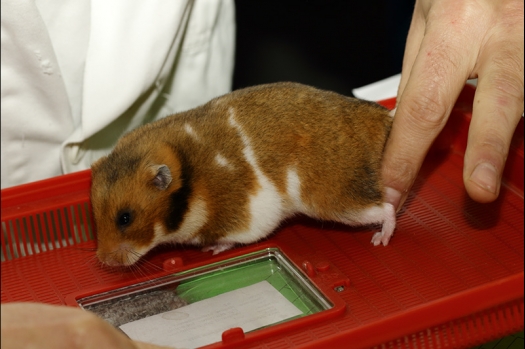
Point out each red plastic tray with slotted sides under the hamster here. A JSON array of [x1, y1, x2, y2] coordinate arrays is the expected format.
[[1, 86, 524, 348]]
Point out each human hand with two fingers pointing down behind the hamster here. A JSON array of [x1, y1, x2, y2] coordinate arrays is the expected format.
[[383, 0, 524, 210]]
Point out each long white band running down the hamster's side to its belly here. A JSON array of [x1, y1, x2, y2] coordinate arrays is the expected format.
[[224, 107, 284, 245]]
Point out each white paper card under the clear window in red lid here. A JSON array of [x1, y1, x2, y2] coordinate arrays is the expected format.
[[120, 281, 302, 348]]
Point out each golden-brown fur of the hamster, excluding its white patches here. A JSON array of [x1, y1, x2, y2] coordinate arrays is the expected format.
[[92, 83, 391, 266]]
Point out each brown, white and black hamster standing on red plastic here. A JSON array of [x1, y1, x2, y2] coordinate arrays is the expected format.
[[91, 83, 396, 266]]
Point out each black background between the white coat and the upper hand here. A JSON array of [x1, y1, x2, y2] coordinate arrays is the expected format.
[[233, 0, 415, 95]]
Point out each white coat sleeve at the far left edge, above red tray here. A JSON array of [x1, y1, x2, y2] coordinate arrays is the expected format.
[[1, 0, 73, 188]]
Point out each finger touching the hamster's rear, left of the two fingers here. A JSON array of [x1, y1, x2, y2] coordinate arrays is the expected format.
[[382, 2, 479, 210]]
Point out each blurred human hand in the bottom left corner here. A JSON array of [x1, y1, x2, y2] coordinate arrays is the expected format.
[[1, 303, 173, 349]]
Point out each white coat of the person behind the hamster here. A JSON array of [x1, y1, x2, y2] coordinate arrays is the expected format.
[[1, 0, 235, 188]]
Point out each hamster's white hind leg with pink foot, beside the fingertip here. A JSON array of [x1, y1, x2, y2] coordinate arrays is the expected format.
[[342, 203, 396, 246]]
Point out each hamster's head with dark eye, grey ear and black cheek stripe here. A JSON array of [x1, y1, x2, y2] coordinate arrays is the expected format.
[[91, 147, 191, 266]]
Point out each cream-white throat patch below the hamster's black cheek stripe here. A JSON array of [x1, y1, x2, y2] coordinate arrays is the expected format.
[[150, 198, 208, 246]]
